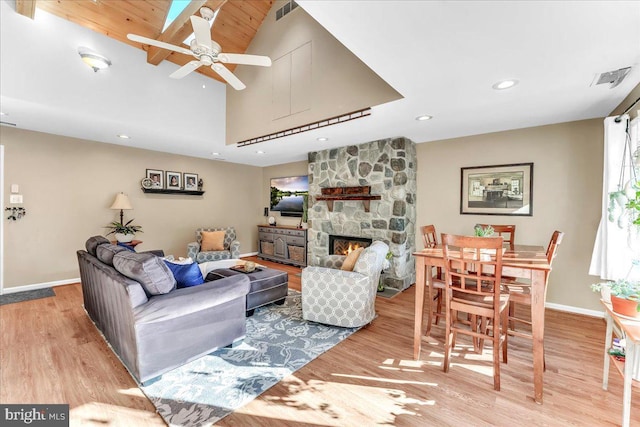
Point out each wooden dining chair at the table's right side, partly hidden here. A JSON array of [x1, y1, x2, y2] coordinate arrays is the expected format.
[[505, 230, 564, 339]]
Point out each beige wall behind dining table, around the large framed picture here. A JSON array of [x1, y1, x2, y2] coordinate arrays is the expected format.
[[416, 119, 603, 311]]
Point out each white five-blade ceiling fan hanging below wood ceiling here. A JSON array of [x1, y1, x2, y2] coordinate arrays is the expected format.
[[127, 7, 271, 90]]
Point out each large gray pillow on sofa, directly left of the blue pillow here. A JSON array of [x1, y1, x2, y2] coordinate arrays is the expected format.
[[113, 251, 176, 295]]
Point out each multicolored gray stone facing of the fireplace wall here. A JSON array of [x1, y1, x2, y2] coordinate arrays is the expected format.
[[307, 138, 417, 290]]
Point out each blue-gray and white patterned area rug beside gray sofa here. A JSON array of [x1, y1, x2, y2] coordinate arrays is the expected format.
[[140, 290, 359, 426]]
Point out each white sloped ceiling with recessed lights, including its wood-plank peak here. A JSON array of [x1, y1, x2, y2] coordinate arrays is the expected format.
[[0, 0, 640, 166]]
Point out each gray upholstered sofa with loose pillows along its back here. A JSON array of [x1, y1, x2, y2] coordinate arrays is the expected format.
[[77, 236, 250, 383]]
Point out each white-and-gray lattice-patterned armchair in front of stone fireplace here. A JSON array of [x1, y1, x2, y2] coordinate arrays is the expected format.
[[302, 241, 389, 328]]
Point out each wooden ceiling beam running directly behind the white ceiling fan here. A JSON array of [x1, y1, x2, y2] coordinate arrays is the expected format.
[[147, 0, 227, 65]]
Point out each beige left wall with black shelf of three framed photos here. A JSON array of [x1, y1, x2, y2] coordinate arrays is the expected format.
[[0, 126, 264, 288]]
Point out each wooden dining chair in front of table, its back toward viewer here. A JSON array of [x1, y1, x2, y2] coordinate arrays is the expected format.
[[442, 233, 509, 390]]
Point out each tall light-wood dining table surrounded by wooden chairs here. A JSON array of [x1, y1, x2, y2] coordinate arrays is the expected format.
[[413, 245, 551, 404]]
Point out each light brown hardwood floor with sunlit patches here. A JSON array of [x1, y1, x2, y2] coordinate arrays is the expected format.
[[0, 258, 640, 426]]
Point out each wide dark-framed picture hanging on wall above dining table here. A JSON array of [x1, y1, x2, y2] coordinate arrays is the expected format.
[[460, 163, 533, 216]]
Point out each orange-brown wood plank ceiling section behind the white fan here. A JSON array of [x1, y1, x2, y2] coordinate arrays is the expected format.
[[16, 0, 274, 83]]
